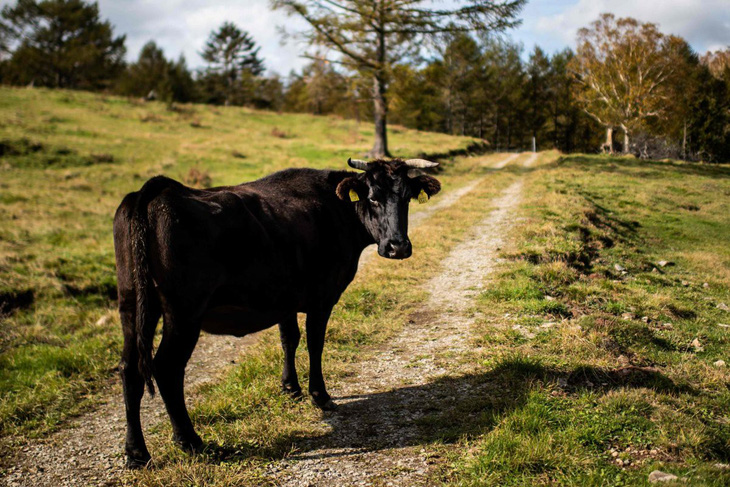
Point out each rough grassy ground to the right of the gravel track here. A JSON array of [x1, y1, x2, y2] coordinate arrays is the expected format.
[[441, 156, 730, 486]]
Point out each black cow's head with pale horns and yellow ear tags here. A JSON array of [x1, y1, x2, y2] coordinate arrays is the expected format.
[[337, 159, 441, 259]]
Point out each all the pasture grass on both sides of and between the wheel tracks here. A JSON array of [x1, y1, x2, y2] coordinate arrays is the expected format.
[[0, 86, 730, 486]]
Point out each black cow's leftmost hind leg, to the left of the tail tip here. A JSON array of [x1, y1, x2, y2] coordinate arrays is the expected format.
[[119, 298, 160, 468]]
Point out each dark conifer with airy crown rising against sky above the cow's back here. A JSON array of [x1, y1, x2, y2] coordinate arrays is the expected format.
[[200, 22, 264, 105]]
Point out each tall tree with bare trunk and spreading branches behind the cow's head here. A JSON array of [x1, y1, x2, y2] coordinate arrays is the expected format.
[[271, 0, 525, 157]]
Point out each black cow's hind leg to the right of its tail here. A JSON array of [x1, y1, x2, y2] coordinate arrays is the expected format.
[[155, 315, 203, 451]]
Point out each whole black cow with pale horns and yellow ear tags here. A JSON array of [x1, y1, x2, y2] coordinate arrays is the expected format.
[[114, 159, 441, 468]]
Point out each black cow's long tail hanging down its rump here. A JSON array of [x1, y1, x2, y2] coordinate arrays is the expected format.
[[130, 176, 170, 396]]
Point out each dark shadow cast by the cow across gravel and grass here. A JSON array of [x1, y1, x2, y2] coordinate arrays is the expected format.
[[196, 359, 695, 462]]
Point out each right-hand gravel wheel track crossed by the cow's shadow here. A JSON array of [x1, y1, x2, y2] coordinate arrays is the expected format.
[[269, 170, 534, 486]]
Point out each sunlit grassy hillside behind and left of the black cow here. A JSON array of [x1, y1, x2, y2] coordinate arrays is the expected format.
[[0, 88, 478, 434]]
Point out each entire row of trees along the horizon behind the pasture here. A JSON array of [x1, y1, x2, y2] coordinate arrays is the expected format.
[[0, 0, 730, 161]]
